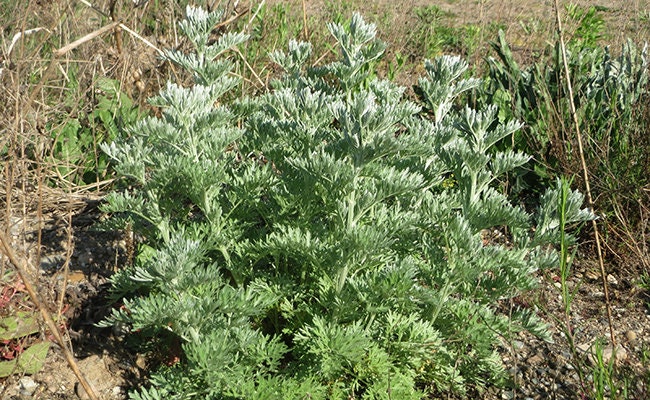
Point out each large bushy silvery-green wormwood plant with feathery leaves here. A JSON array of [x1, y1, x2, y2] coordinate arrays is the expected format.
[[98, 8, 590, 399]]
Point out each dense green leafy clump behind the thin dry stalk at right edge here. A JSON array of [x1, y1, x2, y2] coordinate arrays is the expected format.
[[483, 25, 650, 268]]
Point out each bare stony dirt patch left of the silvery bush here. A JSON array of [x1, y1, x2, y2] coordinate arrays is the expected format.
[[0, 192, 145, 400]]
